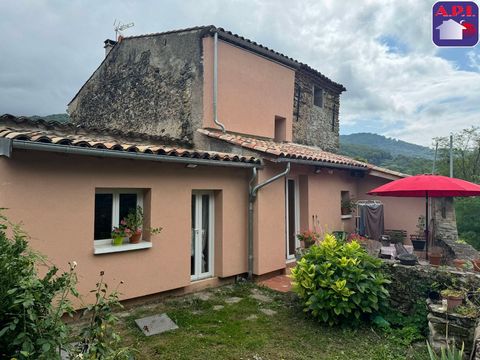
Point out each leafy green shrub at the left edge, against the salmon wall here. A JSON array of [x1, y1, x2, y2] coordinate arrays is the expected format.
[[0, 213, 76, 359]]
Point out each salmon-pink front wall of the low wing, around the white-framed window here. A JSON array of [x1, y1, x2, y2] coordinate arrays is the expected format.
[[0, 150, 250, 299]]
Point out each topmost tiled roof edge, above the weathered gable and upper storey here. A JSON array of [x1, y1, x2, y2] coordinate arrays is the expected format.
[[124, 25, 346, 92]]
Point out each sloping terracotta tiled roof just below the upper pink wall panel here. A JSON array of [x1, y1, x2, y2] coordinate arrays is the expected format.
[[198, 129, 369, 168]]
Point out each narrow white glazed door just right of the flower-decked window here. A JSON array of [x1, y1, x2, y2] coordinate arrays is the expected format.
[[190, 191, 214, 280]]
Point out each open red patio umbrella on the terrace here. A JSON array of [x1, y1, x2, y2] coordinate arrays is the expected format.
[[368, 174, 480, 258]]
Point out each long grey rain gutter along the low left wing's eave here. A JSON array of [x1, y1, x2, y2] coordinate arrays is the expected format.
[[7, 139, 262, 168]]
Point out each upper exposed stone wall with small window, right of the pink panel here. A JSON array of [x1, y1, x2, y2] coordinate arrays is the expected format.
[[293, 71, 340, 152]]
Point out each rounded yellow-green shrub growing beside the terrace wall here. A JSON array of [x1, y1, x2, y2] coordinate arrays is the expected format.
[[291, 235, 389, 325]]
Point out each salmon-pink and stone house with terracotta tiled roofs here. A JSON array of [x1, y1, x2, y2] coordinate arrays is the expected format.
[[0, 26, 424, 299]]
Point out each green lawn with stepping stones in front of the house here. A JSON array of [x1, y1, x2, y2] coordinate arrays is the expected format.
[[118, 284, 428, 360]]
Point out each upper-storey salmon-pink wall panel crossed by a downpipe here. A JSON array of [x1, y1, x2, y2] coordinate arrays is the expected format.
[[203, 37, 295, 141]]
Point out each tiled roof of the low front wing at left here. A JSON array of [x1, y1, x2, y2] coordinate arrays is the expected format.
[[0, 114, 260, 164]]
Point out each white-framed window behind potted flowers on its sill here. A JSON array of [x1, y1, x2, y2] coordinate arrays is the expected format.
[[93, 189, 143, 240]]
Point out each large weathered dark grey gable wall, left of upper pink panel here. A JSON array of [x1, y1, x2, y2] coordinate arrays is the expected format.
[[68, 30, 207, 142]]
